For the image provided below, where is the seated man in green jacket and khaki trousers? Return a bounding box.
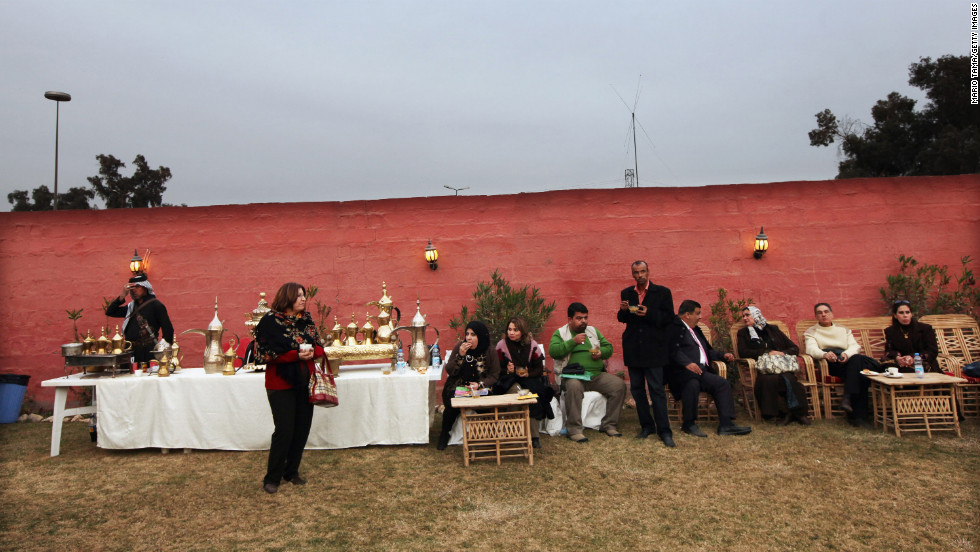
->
[548,303,626,443]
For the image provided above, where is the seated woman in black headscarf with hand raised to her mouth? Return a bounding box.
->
[436,320,500,450]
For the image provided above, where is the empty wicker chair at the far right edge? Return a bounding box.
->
[920,314,980,418]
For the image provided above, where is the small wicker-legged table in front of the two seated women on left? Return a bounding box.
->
[451,393,534,466]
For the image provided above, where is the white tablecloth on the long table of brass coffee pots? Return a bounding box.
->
[97,368,429,450]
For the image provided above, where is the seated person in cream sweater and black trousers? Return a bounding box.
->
[803,303,877,429]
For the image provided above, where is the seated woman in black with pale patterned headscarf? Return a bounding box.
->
[736,307,813,425]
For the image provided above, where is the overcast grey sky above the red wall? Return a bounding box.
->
[0,0,970,210]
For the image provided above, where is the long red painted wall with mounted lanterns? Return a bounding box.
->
[0,175,980,408]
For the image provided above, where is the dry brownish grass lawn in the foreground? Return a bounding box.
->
[0,410,980,552]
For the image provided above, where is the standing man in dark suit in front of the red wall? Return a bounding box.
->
[616,261,674,447]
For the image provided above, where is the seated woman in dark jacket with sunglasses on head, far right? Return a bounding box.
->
[882,299,940,372]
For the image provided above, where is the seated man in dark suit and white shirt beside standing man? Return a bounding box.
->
[667,299,752,437]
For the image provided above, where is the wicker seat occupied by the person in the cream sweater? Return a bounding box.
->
[796,316,892,419]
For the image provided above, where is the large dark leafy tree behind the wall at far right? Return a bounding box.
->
[809,55,980,178]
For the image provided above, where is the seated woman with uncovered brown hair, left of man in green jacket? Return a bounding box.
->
[494,318,555,448]
